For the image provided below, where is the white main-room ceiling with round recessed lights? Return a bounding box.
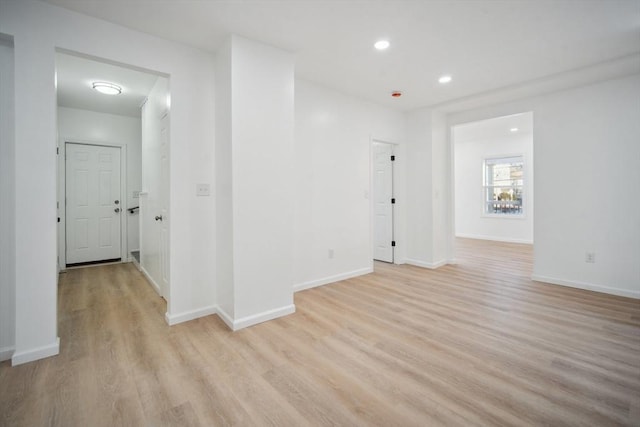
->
[46,0,640,110]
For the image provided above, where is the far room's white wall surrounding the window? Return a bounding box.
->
[454,123,534,243]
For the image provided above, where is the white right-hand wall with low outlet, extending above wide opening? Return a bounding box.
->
[449,74,640,298]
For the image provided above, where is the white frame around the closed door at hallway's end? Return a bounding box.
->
[58,138,130,271]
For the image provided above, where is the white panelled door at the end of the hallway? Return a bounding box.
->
[66,143,122,264]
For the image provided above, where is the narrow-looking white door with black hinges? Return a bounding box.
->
[373,142,393,262]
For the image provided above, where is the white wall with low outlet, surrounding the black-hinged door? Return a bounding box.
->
[292,79,406,290]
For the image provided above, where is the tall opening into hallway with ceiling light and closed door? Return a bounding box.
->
[56,50,170,301]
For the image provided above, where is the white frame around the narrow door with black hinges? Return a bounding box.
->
[366,136,406,269]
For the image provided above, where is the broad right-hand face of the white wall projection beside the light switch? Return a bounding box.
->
[231,36,294,319]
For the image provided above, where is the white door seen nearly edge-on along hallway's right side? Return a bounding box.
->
[158,113,169,301]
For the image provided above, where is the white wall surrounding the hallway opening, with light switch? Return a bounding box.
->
[0,2,215,364]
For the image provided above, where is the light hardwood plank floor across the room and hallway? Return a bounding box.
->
[0,239,640,426]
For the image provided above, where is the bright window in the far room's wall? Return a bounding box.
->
[484,156,524,215]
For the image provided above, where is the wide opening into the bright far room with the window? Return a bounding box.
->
[451,112,534,268]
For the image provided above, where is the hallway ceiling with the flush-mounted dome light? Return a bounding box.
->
[56,53,158,117]
